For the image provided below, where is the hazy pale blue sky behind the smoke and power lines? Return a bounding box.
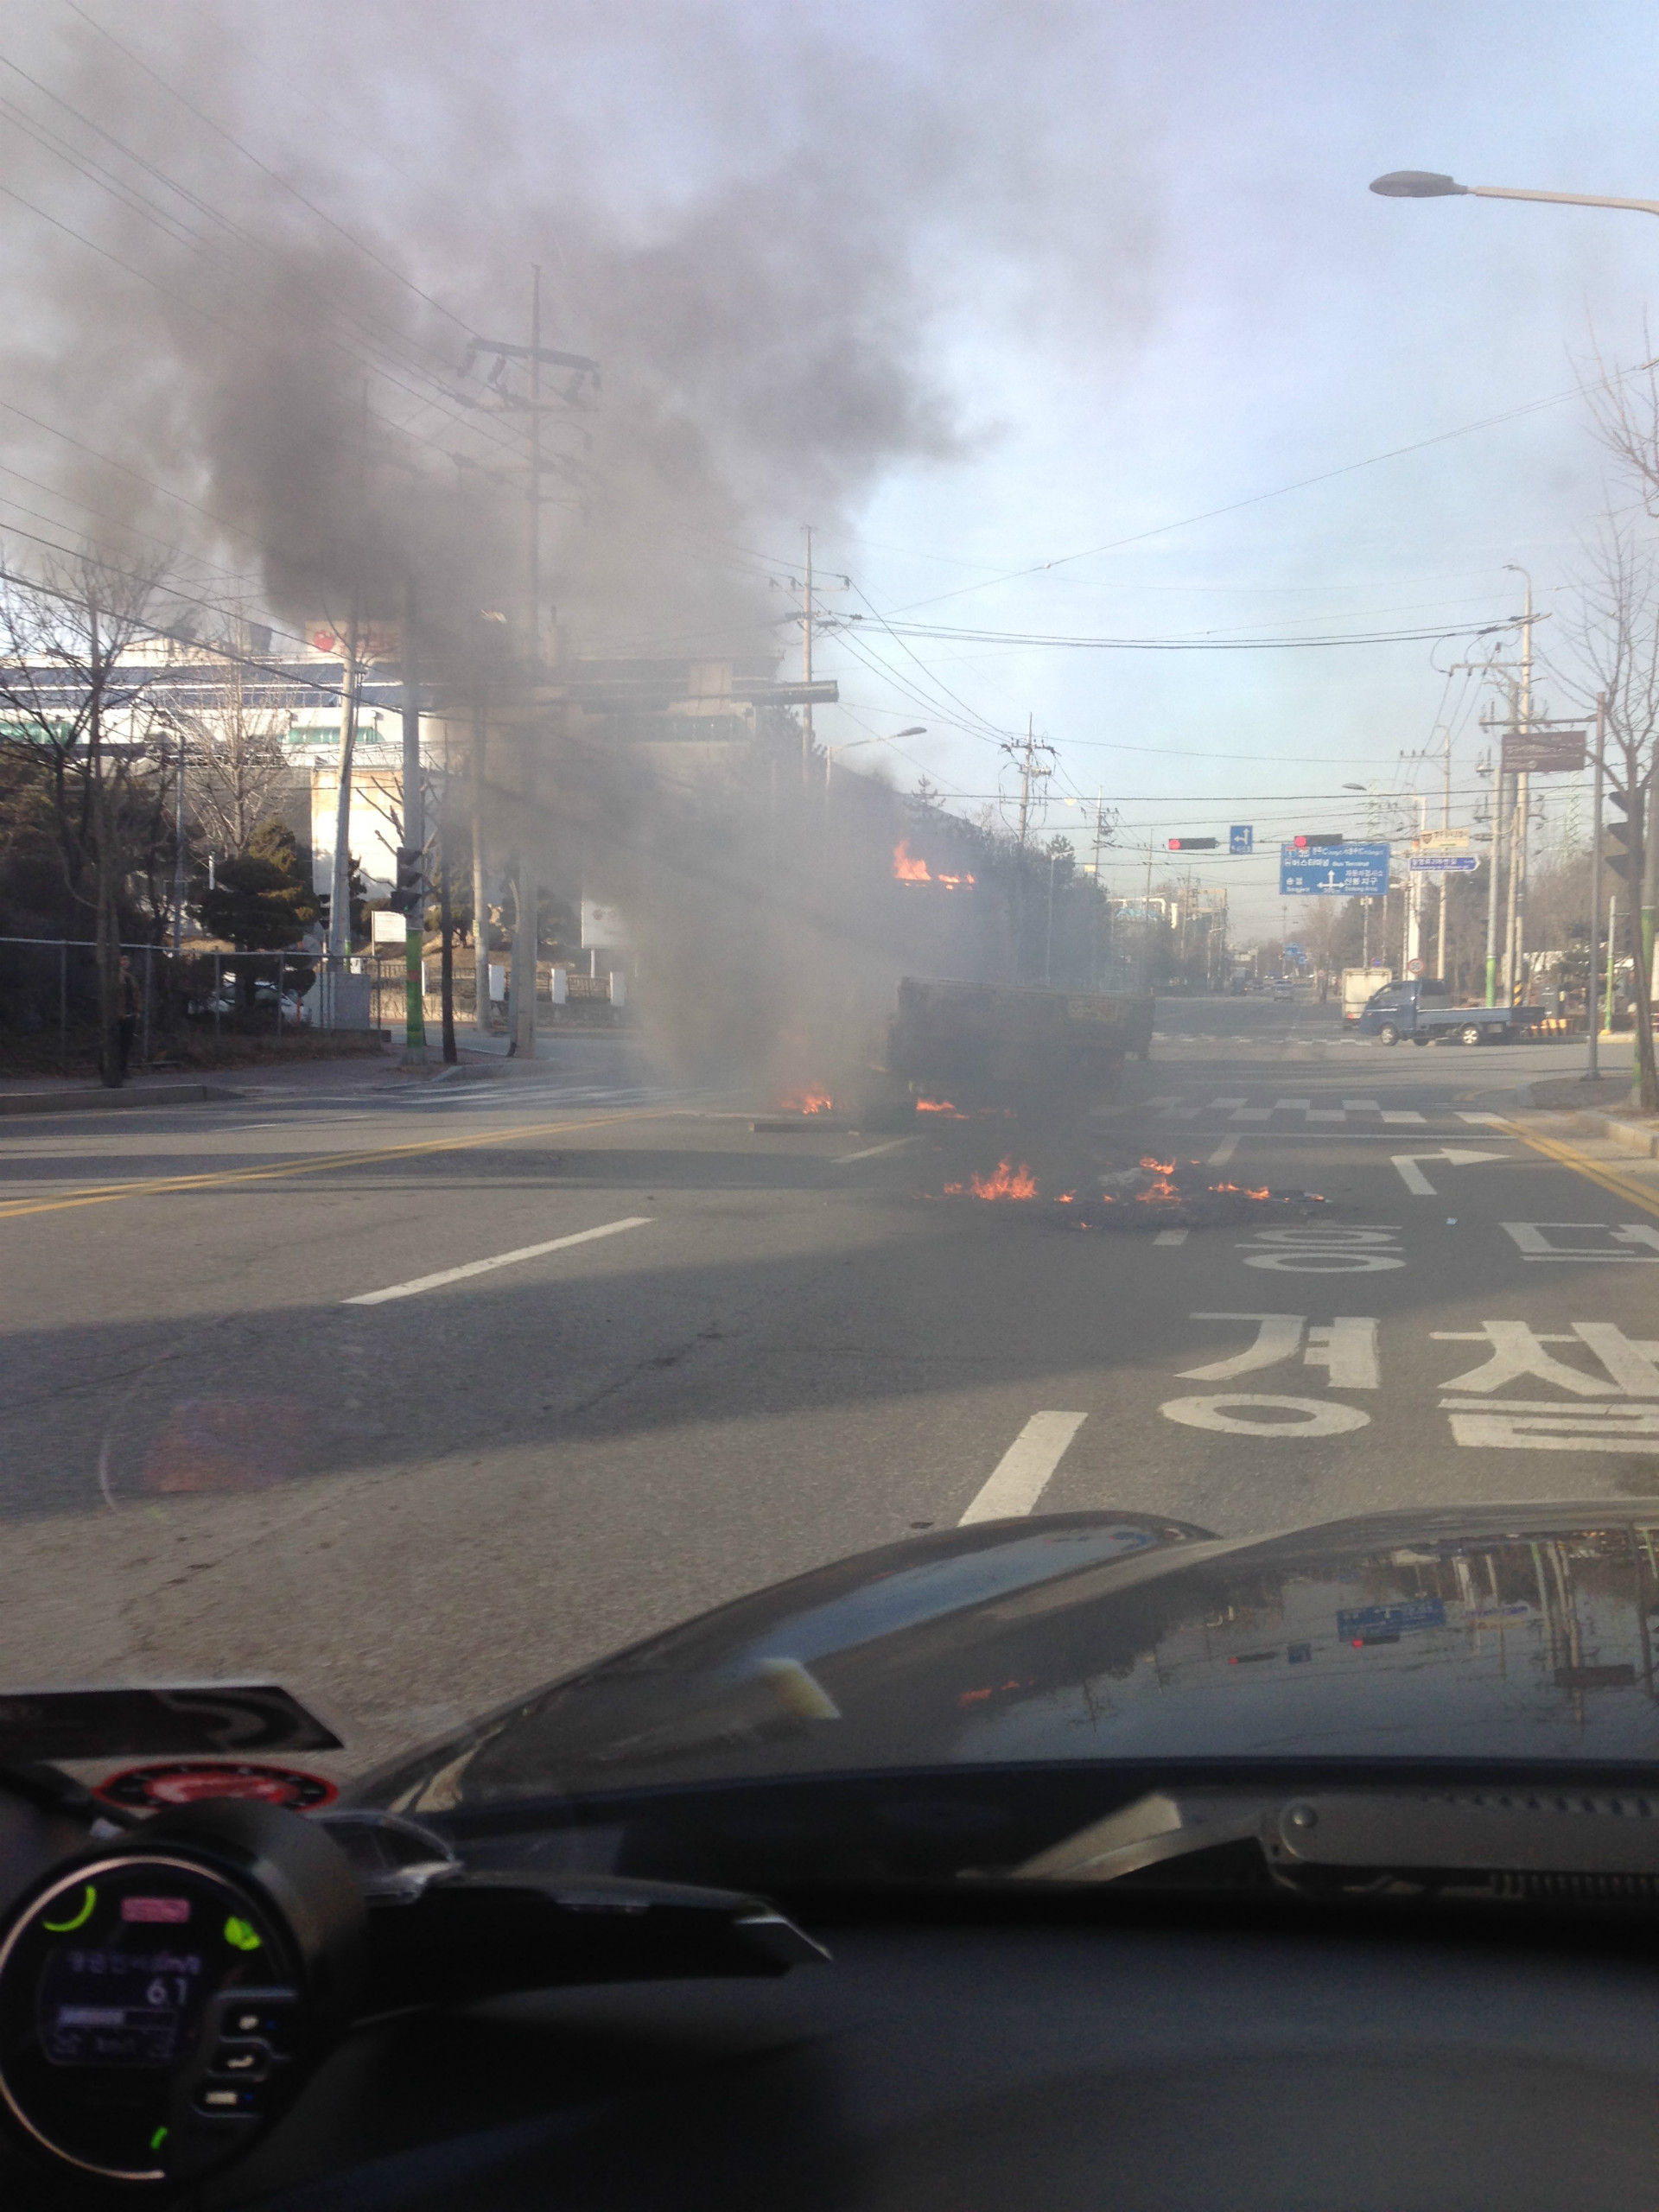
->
[0,0,1659,927]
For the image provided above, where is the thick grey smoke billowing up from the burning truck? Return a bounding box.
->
[0,0,1148,1075]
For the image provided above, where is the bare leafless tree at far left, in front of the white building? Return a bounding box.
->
[0,553,163,1089]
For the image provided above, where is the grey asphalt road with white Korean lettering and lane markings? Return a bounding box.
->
[0,1000,1659,1765]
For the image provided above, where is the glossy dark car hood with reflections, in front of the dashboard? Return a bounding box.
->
[354,1500,1659,1814]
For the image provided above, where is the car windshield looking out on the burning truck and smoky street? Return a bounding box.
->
[0,0,1659,1880]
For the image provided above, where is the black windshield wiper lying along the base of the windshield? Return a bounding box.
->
[1011,1787,1659,1897]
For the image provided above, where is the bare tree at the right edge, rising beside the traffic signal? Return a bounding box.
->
[1555,512,1659,1113]
